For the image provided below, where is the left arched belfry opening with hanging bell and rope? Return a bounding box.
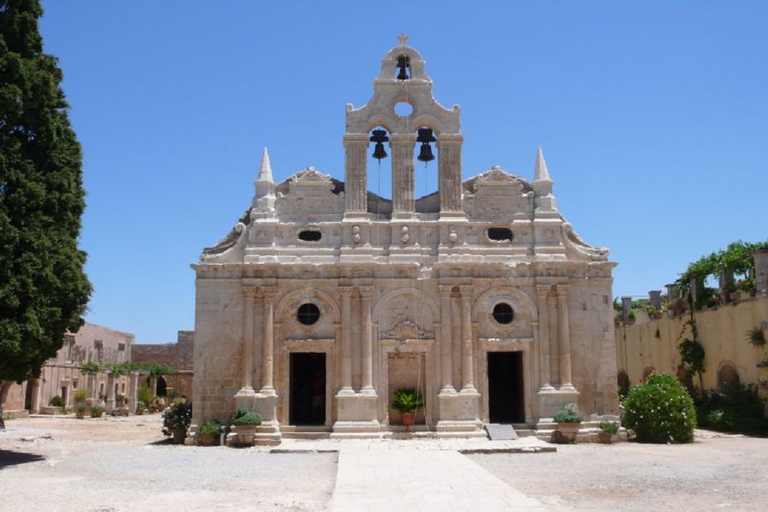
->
[368,125,392,215]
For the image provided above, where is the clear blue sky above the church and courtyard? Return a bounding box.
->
[41,0,768,343]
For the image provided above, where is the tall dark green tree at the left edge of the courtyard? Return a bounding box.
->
[0,0,91,428]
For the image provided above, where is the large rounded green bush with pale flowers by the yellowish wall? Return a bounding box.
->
[624,374,696,443]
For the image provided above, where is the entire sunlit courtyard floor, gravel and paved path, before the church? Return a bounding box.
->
[0,414,768,511]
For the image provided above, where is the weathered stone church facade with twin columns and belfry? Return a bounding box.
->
[193,36,618,442]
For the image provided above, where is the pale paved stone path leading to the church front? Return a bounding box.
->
[331,447,546,512]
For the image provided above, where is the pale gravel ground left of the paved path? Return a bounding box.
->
[0,414,338,512]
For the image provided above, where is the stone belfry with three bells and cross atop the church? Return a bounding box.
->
[344,34,464,220]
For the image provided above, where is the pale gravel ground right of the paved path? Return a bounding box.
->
[470,431,768,512]
